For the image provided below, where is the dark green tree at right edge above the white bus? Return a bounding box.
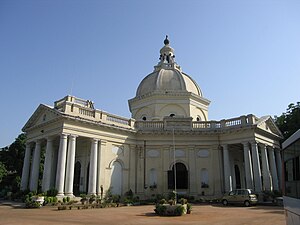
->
[275,102,300,141]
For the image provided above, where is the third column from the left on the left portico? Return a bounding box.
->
[42,137,53,192]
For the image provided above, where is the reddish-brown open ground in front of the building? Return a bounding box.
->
[0,202,285,225]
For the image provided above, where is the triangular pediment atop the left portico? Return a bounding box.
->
[22,104,61,132]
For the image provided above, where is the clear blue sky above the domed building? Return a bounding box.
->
[0,0,300,147]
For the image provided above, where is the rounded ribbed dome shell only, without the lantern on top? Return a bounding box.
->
[136,68,202,97]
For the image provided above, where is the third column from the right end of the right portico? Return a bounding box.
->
[259,143,272,191]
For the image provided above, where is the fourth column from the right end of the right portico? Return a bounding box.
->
[251,141,262,192]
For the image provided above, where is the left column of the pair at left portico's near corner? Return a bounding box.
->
[55,134,68,196]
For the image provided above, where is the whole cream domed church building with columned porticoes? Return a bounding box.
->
[21,37,282,198]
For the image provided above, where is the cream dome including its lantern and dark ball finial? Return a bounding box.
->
[136,36,202,97]
